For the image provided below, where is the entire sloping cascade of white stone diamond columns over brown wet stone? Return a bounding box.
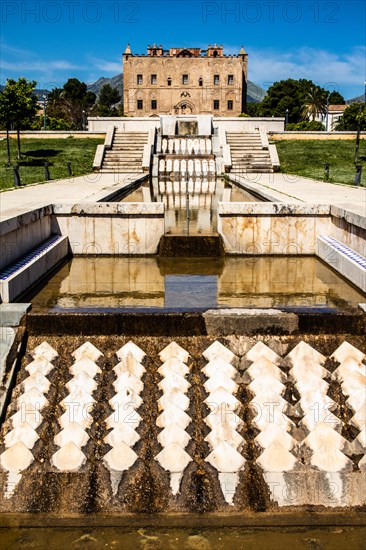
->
[0,339,366,511]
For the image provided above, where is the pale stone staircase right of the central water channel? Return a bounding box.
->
[226,132,274,174]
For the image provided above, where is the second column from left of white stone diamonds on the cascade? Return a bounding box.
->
[51,342,103,472]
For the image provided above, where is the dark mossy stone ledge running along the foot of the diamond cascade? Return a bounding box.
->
[0,507,366,528]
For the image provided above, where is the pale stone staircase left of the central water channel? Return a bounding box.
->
[100,129,148,173]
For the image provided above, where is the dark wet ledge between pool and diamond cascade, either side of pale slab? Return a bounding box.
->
[27,309,366,337]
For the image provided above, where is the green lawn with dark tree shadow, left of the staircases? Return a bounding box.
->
[0,138,104,189]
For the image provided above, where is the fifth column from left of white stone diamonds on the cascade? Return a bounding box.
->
[203,341,245,504]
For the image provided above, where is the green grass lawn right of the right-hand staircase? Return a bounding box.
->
[276,139,366,186]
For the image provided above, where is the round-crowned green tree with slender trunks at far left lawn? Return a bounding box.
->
[0,77,38,160]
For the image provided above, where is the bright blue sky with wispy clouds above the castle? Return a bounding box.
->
[0,0,366,99]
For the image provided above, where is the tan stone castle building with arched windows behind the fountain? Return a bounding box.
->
[123,44,248,117]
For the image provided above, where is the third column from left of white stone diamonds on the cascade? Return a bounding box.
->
[103,342,146,494]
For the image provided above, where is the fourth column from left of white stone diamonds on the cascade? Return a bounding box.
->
[155,342,192,495]
